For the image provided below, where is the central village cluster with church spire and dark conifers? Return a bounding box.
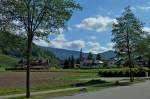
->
[62,49,114,69]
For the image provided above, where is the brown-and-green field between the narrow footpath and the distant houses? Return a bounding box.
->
[0,72,97,95]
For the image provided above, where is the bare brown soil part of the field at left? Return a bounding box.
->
[0,72,80,88]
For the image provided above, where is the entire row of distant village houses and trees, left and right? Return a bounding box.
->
[13,49,148,69]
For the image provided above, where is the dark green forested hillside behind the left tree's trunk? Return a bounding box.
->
[0,32,59,67]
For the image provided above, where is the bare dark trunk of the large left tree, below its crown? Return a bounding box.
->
[26,37,32,98]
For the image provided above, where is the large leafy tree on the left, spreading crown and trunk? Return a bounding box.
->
[0,0,81,98]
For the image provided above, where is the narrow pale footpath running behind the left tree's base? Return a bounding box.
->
[0,87,85,99]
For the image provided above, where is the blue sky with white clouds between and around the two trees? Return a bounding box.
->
[34,0,150,53]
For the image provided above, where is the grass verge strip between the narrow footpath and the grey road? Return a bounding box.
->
[9,80,143,99]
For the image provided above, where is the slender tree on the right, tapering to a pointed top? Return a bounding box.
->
[112,6,143,81]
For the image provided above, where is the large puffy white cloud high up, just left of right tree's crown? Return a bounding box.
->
[76,16,116,32]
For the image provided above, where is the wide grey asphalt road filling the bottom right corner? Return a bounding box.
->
[55,81,150,99]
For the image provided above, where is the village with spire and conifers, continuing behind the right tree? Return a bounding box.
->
[62,49,149,69]
